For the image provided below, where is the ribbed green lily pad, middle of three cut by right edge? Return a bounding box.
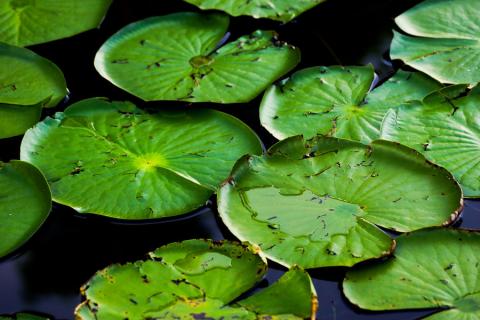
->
[382,86,480,198]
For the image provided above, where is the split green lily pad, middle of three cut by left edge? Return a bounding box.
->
[0,43,67,139]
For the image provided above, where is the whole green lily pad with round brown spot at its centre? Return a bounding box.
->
[95,12,300,103]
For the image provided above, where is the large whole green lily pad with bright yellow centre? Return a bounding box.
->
[21,99,262,219]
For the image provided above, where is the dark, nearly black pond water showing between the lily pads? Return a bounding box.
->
[0,0,480,320]
